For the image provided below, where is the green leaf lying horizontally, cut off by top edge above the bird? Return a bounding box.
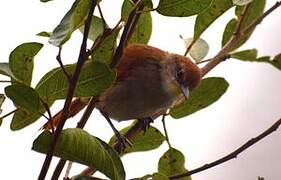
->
[156,0,212,17]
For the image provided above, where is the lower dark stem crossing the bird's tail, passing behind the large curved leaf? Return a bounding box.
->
[51,97,97,180]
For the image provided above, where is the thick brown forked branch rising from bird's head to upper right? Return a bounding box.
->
[201,1,281,77]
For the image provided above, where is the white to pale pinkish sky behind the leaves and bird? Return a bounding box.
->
[0,0,281,180]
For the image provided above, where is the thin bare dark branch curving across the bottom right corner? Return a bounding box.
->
[169,119,281,179]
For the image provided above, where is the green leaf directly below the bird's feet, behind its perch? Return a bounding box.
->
[109,123,165,154]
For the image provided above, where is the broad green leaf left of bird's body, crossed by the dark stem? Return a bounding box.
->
[35,61,115,103]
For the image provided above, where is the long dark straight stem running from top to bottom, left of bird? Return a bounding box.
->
[38,0,97,180]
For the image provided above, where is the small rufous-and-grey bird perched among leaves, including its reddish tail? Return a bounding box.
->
[44,44,201,148]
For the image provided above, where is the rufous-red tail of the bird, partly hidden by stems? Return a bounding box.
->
[41,98,89,130]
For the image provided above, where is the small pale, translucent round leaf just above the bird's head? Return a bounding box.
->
[184,38,210,63]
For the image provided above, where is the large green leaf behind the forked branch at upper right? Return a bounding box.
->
[222,0,266,50]
